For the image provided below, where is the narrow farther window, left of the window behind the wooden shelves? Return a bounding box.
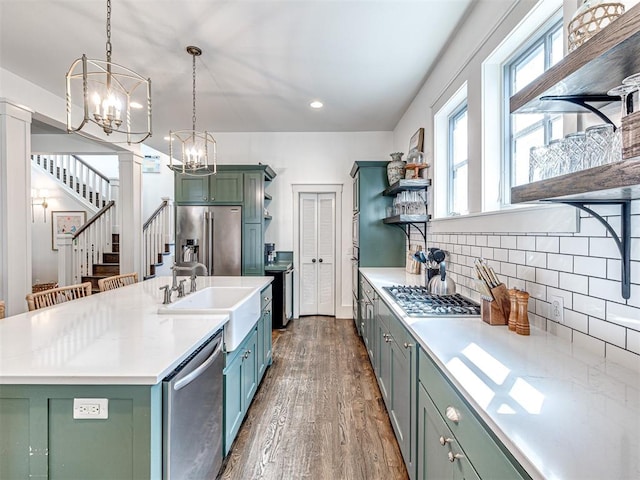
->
[447,102,469,215]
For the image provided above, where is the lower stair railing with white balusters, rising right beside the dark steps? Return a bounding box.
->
[72,200,116,283]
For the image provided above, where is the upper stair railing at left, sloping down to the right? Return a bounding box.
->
[31,154,113,209]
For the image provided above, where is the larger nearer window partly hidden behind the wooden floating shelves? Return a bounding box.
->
[504,19,563,191]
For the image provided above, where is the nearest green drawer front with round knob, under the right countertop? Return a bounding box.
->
[418,349,530,480]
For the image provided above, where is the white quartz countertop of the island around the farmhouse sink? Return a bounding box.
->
[0,277,273,385]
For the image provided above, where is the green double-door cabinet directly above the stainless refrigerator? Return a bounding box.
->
[175,172,244,204]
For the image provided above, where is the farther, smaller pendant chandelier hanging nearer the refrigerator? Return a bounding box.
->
[169,45,217,176]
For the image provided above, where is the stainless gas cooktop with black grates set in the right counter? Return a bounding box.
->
[382,285,480,317]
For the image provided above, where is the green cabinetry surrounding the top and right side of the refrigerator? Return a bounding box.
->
[175,165,276,276]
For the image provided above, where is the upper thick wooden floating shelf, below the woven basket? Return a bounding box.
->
[510,5,640,113]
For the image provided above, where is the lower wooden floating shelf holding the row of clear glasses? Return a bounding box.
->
[511,158,640,203]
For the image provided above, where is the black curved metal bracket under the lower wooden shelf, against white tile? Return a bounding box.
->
[548,199,631,300]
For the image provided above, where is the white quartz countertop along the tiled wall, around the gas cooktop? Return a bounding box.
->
[360,268,640,480]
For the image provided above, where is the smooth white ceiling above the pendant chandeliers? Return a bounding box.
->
[0,0,472,151]
